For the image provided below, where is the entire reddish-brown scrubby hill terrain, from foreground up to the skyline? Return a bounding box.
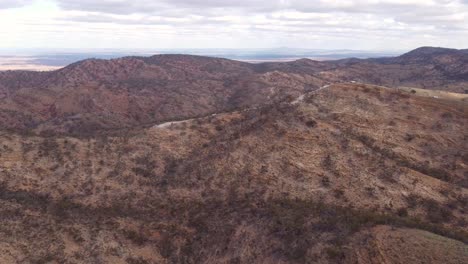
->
[0,48,468,263]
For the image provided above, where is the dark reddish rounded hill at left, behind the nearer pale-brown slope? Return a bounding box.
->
[0,55,322,135]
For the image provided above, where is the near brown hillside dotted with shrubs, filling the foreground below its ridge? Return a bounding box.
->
[0,83,468,263]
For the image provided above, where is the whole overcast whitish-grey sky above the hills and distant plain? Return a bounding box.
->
[0,0,468,50]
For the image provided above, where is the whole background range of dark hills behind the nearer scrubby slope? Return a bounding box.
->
[0,48,468,136]
